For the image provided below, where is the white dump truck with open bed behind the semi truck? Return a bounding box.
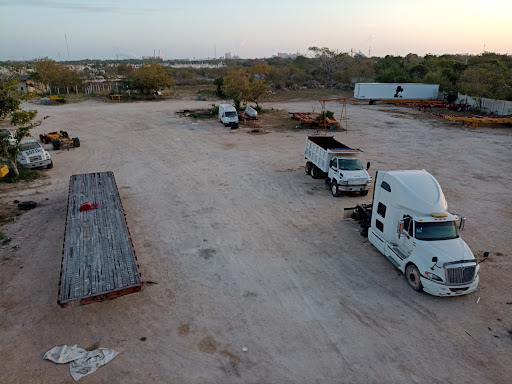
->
[304,136,372,197]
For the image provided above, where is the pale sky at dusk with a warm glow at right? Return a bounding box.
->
[0,0,512,60]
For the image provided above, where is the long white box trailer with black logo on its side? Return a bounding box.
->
[354,83,439,104]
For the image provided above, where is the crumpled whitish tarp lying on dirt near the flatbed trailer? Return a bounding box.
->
[43,344,118,381]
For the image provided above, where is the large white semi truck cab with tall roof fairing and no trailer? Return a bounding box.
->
[345,170,489,296]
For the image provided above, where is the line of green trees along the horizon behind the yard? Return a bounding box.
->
[0,47,512,100]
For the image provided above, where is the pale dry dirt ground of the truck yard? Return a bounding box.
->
[0,97,512,384]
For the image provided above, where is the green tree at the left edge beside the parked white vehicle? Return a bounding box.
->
[0,78,48,176]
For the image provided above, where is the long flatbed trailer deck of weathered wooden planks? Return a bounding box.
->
[58,172,143,307]
